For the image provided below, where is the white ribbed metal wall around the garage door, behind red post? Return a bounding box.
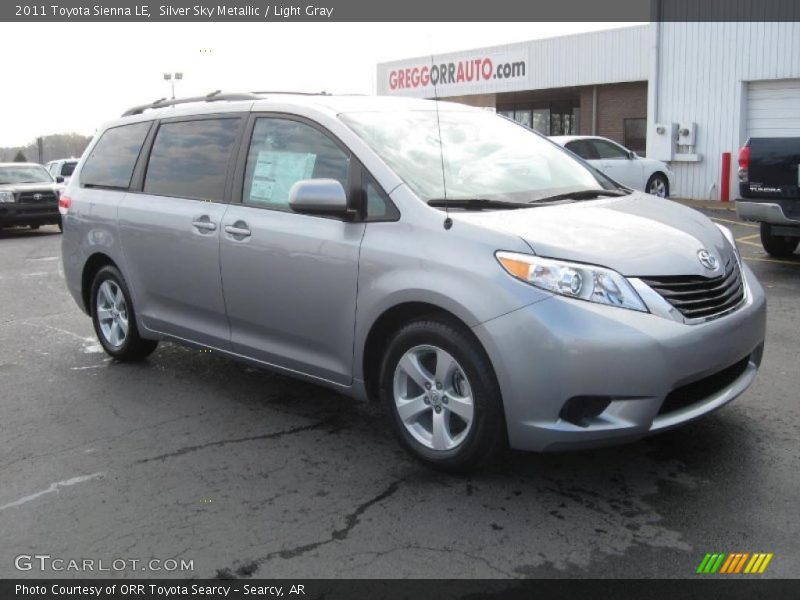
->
[647,22,800,199]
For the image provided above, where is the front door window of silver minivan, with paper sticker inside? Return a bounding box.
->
[242,117,350,210]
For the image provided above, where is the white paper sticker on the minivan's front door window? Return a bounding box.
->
[250,150,317,204]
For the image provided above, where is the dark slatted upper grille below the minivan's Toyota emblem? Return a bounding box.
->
[641,258,744,319]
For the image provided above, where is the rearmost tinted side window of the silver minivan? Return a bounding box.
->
[81,122,150,190]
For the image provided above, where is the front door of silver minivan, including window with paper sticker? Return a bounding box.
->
[221,117,365,384]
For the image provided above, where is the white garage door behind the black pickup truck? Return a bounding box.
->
[747,79,800,137]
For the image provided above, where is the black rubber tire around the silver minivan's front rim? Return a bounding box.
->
[379,317,507,472]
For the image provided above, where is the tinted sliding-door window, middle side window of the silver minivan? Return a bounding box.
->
[144,119,240,201]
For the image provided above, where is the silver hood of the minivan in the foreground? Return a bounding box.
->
[451,193,733,277]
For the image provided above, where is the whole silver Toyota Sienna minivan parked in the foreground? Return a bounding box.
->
[60,94,766,469]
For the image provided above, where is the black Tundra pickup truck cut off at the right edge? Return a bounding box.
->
[736,137,800,257]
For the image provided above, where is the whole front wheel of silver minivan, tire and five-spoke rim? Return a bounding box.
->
[380,318,505,471]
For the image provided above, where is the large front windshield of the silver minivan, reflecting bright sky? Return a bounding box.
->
[340,109,616,202]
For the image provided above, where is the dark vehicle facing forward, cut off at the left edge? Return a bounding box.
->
[0,163,61,229]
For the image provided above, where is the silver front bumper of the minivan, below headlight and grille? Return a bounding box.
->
[474,266,766,451]
